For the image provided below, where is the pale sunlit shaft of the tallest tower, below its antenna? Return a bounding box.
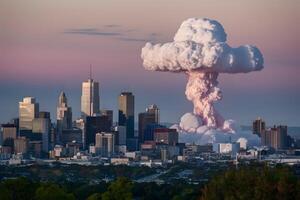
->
[81,78,100,117]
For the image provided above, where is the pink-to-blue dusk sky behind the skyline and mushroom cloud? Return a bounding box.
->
[0,1,300,126]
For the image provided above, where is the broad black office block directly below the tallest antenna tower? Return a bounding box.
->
[84,116,110,149]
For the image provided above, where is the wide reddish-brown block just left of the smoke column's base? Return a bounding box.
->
[154,128,178,146]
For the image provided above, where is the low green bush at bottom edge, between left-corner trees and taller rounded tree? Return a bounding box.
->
[35,183,75,200]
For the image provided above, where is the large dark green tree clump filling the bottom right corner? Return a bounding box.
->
[201,167,300,200]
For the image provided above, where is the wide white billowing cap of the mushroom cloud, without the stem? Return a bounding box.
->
[141,18,264,73]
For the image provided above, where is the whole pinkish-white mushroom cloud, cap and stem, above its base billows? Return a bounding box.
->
[141,18,263,132]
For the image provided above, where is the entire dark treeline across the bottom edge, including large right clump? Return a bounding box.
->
[0,167,300,200]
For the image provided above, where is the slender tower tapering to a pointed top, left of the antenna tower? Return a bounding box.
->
[56,92,72,131]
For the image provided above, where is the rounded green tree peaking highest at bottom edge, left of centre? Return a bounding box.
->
[101,177,133,200]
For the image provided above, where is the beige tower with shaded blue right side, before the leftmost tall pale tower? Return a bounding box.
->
[30,112,51,152]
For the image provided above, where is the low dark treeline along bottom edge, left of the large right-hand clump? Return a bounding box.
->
[0,177,200,200]
